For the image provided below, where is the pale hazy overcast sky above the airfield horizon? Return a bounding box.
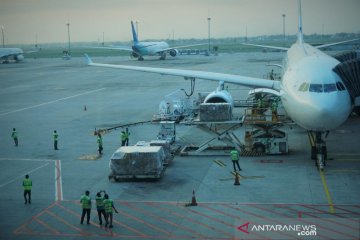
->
[0,0,360,44]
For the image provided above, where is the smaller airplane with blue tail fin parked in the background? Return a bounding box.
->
[96,21,204,61]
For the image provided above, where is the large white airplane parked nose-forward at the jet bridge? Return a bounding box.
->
[86,0,360,170]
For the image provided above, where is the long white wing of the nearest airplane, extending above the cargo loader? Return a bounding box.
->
[85,54,280,90]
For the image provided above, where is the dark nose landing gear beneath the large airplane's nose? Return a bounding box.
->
[309,131,329,171]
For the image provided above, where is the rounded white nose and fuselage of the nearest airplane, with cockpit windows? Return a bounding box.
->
[280,42,352,132]
